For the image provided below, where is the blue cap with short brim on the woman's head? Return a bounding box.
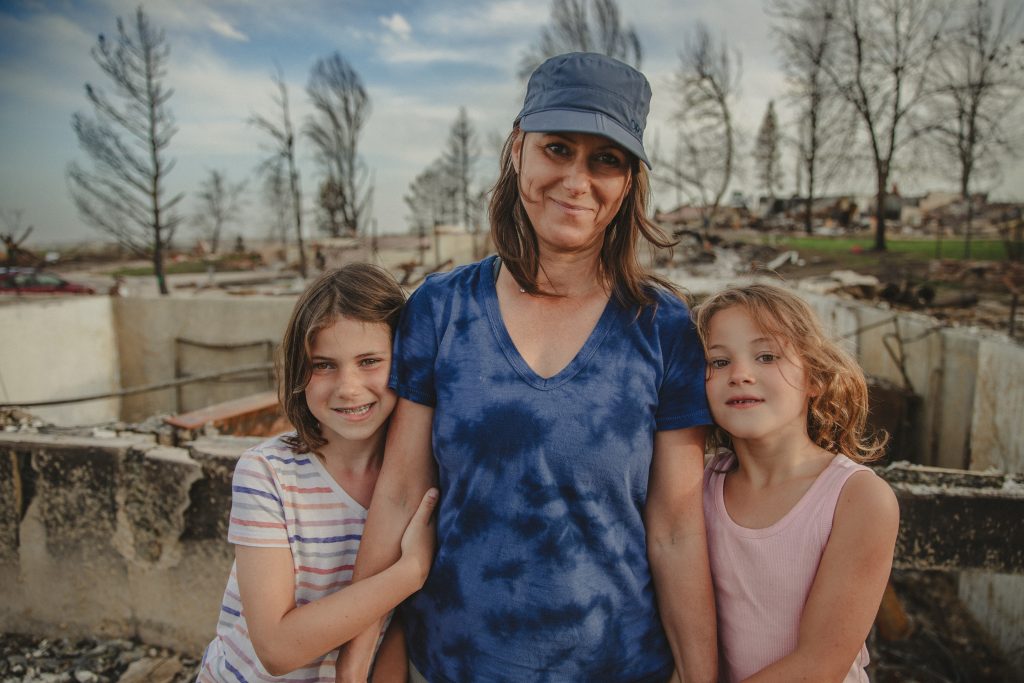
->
[516,52,651,168]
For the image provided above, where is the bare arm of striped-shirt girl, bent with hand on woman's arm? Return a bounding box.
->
[234,489,437,676]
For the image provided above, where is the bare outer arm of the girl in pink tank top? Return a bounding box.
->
[746,472,899,683]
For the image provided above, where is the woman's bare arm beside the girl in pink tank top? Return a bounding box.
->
[644,427,718,683]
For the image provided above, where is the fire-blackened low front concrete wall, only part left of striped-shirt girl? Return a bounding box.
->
[0,434,247,653]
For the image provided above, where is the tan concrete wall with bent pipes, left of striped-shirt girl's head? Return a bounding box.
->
[114,296,295,422]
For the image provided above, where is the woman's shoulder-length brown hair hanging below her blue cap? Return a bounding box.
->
[488,124,683,306]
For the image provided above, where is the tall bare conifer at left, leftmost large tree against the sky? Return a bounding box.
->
[68,7,183,294]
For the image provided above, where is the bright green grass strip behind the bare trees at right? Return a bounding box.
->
[774,237,1008,261]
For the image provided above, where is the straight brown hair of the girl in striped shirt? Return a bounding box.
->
[278,263,406,453]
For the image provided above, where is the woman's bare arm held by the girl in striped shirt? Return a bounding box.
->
[337,398,437,683]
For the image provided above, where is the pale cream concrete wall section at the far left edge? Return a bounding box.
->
[0,296,121,426]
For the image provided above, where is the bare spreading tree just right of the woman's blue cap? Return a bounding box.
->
[657,22,740,226]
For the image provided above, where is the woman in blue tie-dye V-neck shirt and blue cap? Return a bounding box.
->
[339,53,717,683]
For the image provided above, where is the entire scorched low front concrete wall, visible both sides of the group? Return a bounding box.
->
[0,433,1024,667]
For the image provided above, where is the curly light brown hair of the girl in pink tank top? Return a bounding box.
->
[693,285,889,463]
